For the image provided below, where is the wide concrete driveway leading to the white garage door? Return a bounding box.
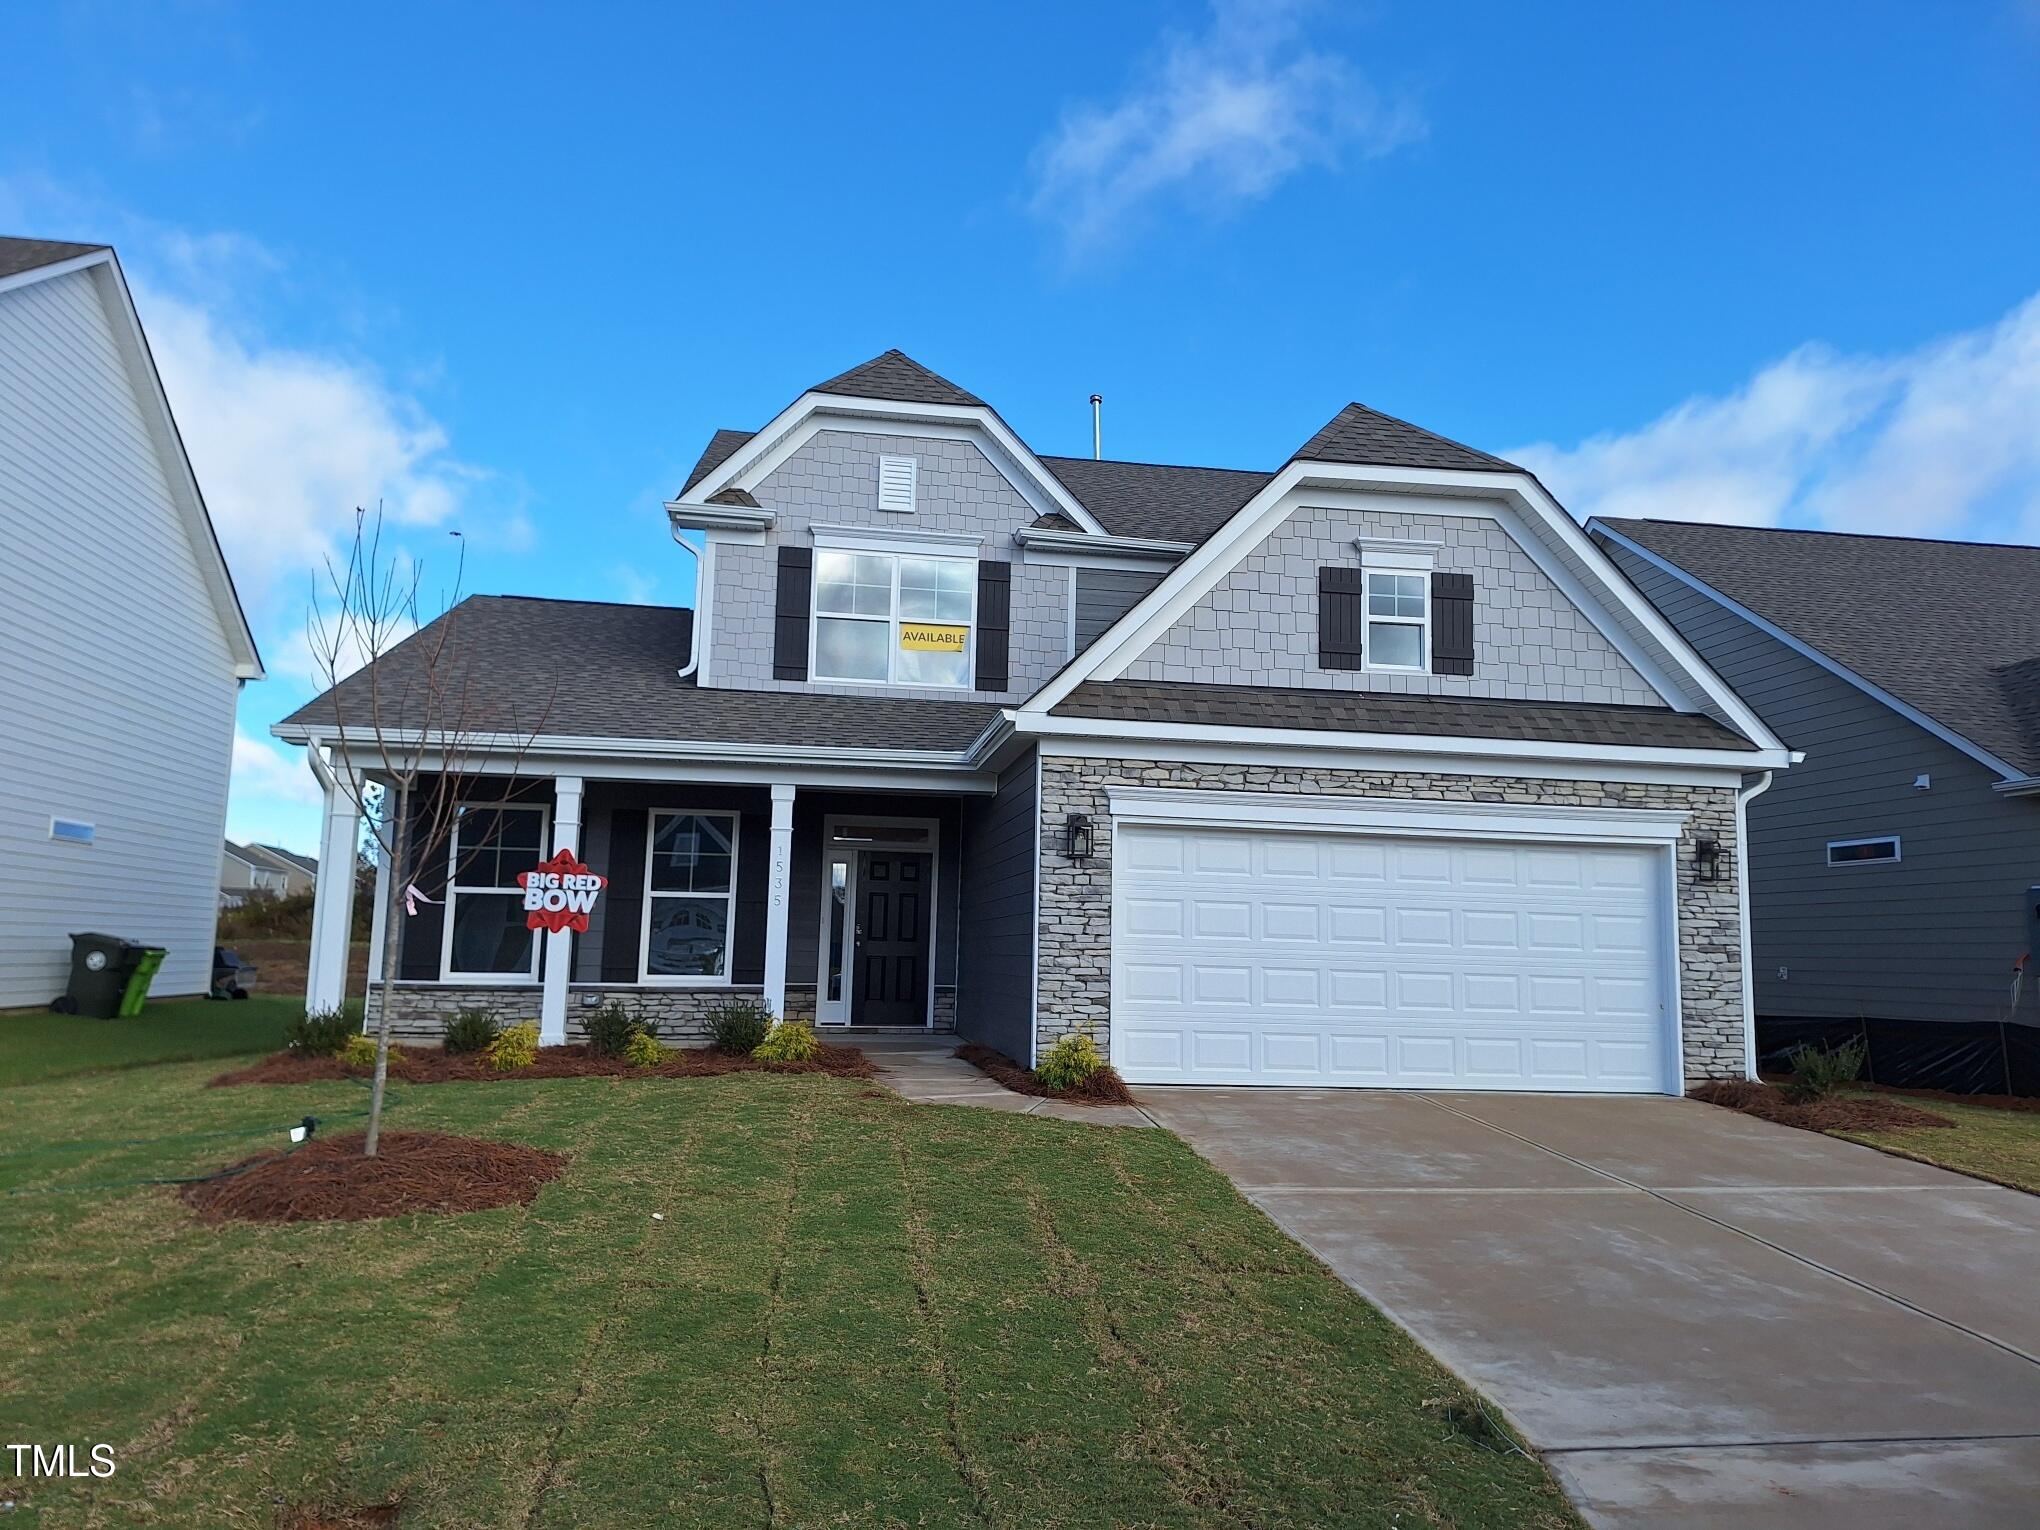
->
[1138,1087,2040,1530]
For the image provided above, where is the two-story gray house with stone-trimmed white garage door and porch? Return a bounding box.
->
[275,351,1785,1091]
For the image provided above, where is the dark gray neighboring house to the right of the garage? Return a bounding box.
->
[1589,520,2040,1093]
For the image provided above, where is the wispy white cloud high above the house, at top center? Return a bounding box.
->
[1028,0,1422,255]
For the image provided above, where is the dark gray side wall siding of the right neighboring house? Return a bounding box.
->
[1610,547,2040,1020]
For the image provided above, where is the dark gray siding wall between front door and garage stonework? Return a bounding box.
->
[957,751,1034,1063]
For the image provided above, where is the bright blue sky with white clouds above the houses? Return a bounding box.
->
[0,0,2040,849]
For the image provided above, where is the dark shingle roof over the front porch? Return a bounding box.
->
[284,596,1000,753]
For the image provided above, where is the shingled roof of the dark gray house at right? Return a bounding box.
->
[1589,518,2040,775]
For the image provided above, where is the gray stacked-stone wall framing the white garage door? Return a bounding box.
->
[1034,757,1744,1087]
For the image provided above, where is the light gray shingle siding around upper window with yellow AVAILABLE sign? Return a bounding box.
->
[708,430,1069,702]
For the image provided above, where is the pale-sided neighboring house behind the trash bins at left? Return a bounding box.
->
[0,239,261,1006]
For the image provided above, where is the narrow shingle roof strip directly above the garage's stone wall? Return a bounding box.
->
[1055,679,1754,749]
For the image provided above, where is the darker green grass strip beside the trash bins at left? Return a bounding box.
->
[0,996,304,1087]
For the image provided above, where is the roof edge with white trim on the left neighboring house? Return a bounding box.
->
[0,237,263,679]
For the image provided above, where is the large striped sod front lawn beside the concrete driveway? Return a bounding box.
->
[0,1052,1577,1530]
